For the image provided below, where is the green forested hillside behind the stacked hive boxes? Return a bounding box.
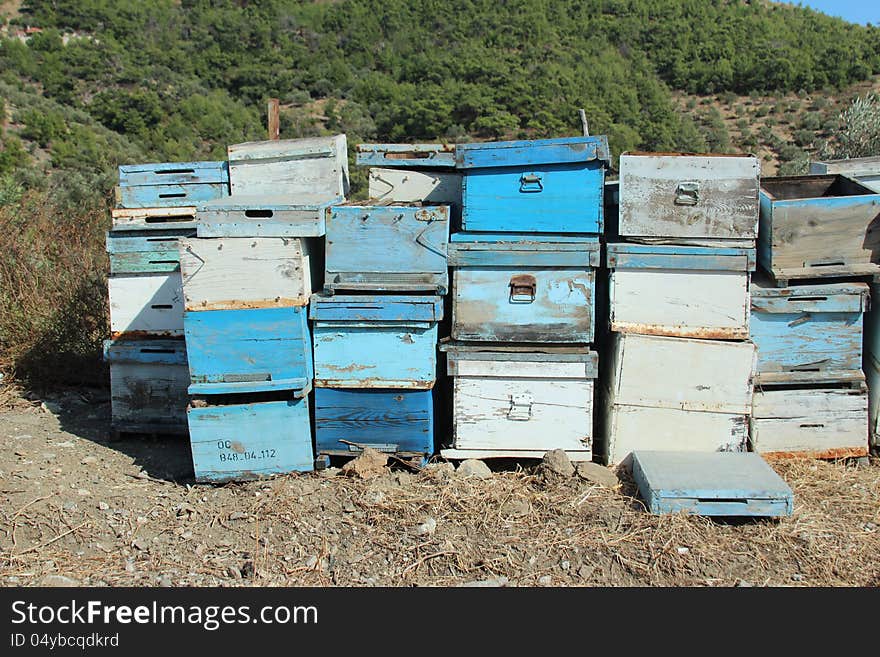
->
[0,0,880,384]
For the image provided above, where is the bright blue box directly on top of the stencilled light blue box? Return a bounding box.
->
[183,306,312,395]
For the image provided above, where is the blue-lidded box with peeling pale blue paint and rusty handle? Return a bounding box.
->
[449,233,600,344]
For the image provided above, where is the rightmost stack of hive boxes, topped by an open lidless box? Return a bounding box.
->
[751,167,880,458]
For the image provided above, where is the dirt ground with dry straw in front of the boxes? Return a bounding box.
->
[0,390,880,586]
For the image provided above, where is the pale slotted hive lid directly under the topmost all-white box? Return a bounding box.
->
[196,195,343,237]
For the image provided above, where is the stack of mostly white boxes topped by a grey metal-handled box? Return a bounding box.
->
[603,153,760,463]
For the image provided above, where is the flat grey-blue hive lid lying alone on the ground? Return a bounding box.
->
[632,450,794,517]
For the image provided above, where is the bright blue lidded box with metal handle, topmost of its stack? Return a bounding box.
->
[455,136,610,234]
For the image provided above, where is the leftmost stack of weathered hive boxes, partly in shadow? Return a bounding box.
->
[104,162,229,434]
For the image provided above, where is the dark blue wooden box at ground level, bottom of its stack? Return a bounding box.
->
[315,388,434,457]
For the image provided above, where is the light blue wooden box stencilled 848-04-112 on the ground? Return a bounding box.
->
[187,399,315,483]
